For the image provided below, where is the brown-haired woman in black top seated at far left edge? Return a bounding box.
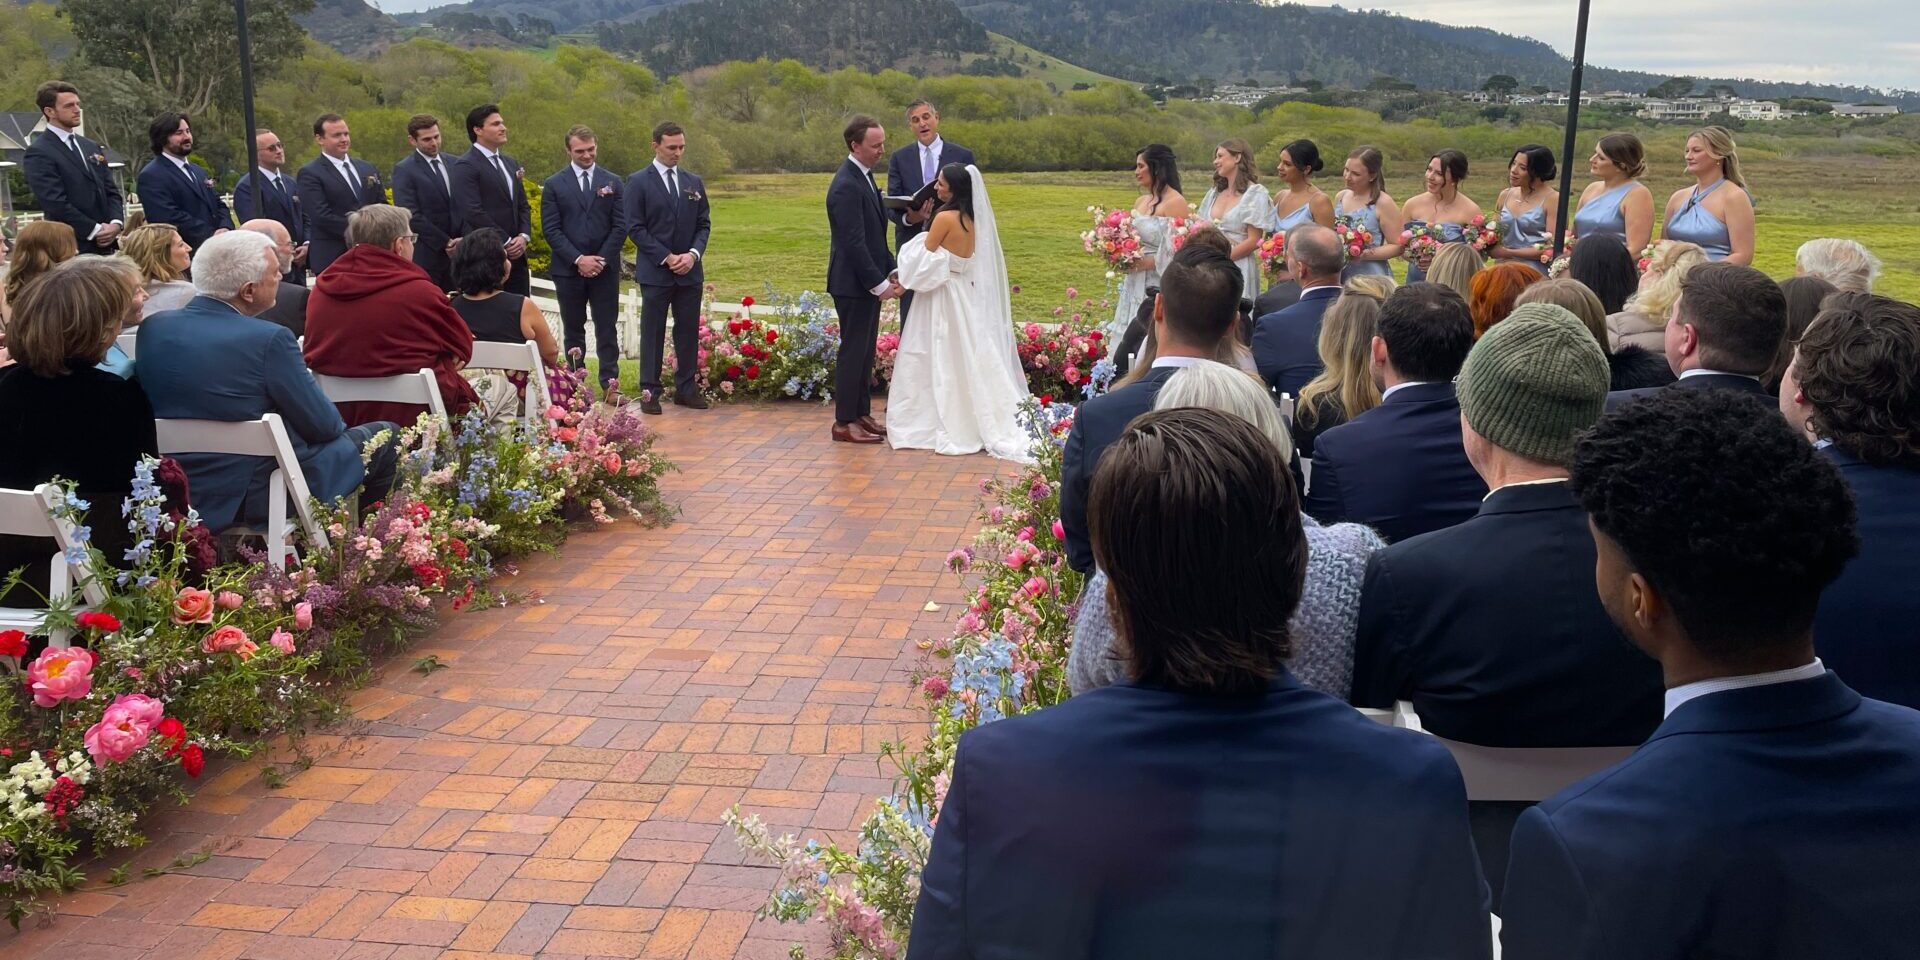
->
[0,255,159,607]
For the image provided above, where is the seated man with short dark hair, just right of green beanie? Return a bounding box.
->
[1607,261,1788,411]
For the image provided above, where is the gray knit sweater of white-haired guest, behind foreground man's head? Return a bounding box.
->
[1068,515,1386,701]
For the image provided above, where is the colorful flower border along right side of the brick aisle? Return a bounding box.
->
[728,401,1083,960]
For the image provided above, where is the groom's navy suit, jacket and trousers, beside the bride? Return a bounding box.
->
[828,157,893,424]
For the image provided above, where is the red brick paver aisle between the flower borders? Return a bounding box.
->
[11,403,1000,960]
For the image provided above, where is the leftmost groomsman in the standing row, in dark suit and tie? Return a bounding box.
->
[23,81,127,253]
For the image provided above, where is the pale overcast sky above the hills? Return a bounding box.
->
[366,0,1920,88]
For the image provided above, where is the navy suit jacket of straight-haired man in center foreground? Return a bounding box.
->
[906,674,1492,960]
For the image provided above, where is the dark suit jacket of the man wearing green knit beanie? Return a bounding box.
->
[1354,484,1665,747]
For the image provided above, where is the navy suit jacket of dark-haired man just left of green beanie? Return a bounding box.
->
[1308,382,1486,543]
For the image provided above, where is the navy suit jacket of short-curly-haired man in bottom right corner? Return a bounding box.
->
[1501,672,1920,960]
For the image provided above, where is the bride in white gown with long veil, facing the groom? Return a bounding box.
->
[887,163,1031,463]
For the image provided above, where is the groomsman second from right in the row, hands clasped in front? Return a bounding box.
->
[540,127,626,386]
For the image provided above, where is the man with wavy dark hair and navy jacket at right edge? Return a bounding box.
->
[1780,295,1920,708]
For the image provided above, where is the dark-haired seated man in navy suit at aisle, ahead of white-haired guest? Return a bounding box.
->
[1060,244,1240,574]
